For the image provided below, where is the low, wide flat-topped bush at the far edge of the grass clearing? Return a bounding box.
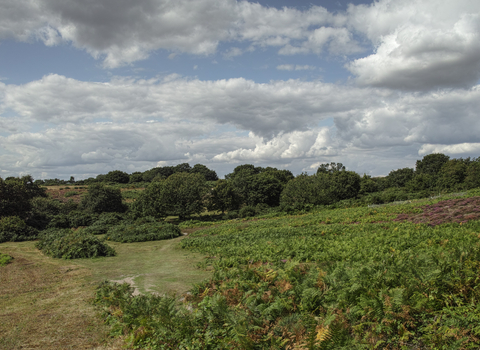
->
[107,222,181,243]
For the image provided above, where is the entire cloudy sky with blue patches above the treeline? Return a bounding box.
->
[0,0,480,179]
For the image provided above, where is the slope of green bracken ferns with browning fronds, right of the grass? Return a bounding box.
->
[97,193,480,349]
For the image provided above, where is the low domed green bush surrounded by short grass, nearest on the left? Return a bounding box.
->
[36,229,116,259]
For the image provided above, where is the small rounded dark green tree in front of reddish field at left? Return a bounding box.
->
[80,183,126,214]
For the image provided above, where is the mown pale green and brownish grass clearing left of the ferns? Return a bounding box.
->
[0,237,209,350]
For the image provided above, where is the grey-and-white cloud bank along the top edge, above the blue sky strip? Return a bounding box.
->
[0,0,356,68]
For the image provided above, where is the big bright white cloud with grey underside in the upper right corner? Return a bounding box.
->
[347,0,480,91]
